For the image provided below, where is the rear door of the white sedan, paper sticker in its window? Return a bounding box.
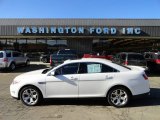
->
[79,62,116,97]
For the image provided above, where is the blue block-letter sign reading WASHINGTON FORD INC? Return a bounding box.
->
[17,27,141,35]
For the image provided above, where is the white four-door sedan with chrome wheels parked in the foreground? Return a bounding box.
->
[10,58,150,107]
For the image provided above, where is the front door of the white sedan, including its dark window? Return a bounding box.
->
[46,63,79,98]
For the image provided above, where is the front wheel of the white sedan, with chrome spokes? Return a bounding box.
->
[20,86,42,106]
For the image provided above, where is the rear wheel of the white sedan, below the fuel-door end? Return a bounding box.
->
[107,87,131,108]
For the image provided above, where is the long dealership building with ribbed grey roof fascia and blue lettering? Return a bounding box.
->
[0,19,160,54]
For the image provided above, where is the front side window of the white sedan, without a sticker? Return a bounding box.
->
[55,63,79,75]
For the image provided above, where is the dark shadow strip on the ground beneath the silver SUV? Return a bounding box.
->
[0,64,48,73]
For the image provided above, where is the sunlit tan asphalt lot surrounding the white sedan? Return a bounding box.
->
[0,63,160,120]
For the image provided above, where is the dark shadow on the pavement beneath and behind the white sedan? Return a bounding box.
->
[41,88,160,108]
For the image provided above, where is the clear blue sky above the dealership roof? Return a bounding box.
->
[0,0,160,18]
